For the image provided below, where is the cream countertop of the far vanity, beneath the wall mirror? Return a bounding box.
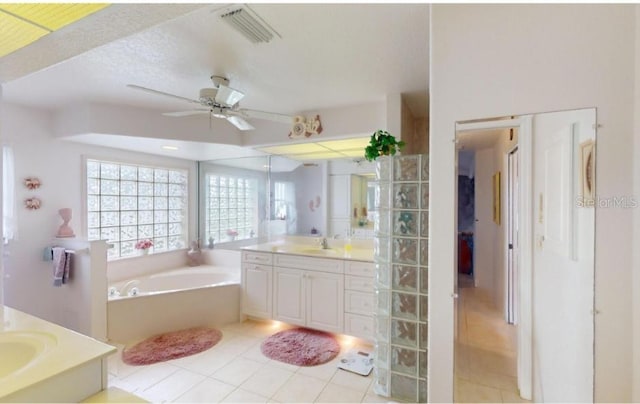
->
[242,242,373,262]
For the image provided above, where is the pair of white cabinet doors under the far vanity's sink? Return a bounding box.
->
[273,254,344,333]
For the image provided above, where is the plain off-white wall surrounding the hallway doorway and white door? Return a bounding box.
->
[429,4,635,401]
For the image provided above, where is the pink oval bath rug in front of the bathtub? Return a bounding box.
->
[122,327,222,366]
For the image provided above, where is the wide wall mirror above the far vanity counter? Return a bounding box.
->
[198,155,375,245]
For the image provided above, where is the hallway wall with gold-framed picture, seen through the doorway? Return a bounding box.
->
[473,148,496,296]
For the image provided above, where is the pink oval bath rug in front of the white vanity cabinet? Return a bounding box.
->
[260,328,340,366]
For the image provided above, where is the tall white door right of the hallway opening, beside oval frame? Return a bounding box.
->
[533,109,596,402]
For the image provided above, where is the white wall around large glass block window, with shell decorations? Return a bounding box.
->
[0,104,196,324]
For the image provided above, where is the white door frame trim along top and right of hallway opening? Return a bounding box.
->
[453,115,533,400]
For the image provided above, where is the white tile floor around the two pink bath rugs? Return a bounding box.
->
[108,321,389,403]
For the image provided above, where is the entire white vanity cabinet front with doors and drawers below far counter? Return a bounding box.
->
[242,249,375,341]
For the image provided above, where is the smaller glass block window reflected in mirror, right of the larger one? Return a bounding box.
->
[205,174,258,242]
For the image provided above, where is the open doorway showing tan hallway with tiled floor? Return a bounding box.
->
[454,124,520,402]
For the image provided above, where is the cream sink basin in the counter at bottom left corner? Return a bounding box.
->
[0,331,57,379]
